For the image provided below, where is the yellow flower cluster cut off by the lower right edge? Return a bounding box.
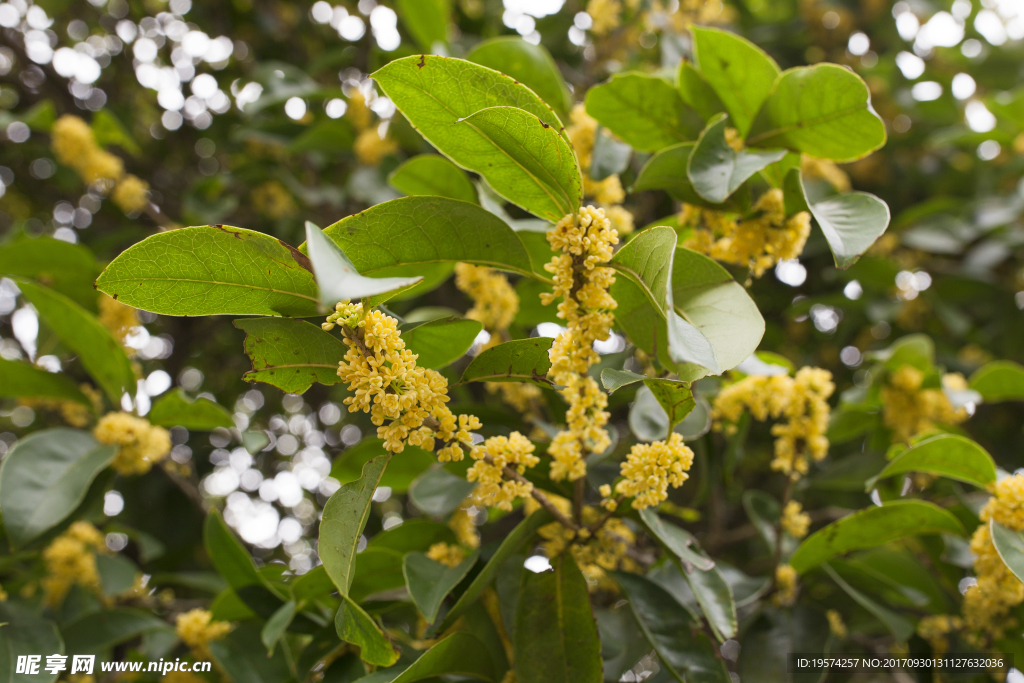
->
[963,474,1024,640]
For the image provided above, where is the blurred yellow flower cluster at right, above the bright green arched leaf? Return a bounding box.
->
[881,366,970,443]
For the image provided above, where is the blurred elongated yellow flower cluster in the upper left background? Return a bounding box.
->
[50,114,150,214]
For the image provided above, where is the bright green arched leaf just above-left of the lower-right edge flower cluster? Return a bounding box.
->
[865,434,995,492]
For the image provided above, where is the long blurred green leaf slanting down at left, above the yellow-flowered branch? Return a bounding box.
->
[14,278,135,405]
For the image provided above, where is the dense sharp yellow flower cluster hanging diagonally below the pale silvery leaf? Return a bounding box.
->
[331,302,480,462]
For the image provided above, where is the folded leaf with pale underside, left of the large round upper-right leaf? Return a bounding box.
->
[686,115,786,204]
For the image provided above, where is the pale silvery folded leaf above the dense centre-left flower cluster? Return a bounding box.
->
[305,220,423,307]
